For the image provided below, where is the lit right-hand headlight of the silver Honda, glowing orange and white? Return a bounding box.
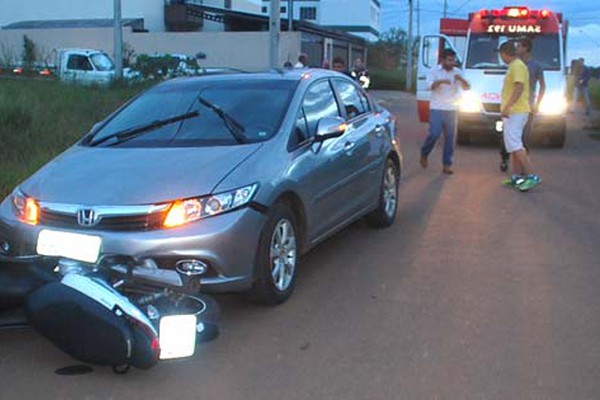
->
[163,183,258,228]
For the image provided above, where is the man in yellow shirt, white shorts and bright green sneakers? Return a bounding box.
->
[500,40,542,192]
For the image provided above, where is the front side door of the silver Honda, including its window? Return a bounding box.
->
[290,79,364,242]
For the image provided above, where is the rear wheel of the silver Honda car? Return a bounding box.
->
[367,158,400,228]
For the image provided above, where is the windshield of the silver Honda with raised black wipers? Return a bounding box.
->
[84,80,297,147]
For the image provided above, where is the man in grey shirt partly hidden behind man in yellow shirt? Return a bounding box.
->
[500,37,546,171]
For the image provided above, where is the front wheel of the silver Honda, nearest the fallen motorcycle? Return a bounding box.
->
[250,203,300,305]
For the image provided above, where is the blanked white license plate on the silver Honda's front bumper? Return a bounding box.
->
[36,229,102,263]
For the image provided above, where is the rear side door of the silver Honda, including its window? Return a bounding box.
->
[333,79,385,214]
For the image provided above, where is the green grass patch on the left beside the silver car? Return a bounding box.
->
[0,80,147,199]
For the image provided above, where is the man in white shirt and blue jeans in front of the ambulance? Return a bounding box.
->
[421,49,471,175]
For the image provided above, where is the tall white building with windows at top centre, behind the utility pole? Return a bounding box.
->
[261,0,381,41]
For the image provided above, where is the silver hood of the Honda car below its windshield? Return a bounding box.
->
[20,144,262,205]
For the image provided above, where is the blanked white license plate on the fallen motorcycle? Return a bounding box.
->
[158,315,197,360]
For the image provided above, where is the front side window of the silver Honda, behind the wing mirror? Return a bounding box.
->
[302,80,340,137]
